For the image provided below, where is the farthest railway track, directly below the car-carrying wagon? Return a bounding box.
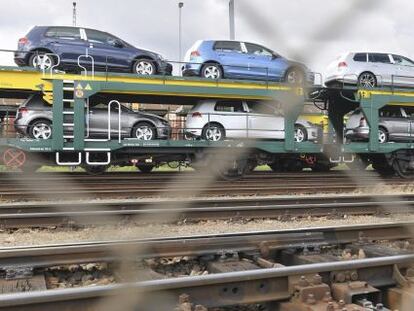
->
[0,172,410,200]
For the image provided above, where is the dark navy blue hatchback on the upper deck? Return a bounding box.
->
[14,26,172,75]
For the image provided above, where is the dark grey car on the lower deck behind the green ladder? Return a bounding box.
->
[14,95,171,140]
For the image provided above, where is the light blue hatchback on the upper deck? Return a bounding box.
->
[182,40,314,84]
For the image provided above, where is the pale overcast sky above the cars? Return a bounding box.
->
[0,0,414,72]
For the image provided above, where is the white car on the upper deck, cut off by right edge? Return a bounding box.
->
[325,52,414,88]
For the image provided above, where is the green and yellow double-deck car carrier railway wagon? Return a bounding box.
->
[0,62,414,178]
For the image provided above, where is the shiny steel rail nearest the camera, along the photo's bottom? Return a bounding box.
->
[0,254,414,311]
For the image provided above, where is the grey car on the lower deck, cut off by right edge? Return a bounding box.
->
[345,106,414,143]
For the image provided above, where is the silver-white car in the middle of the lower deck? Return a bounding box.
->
[184,100,321,142]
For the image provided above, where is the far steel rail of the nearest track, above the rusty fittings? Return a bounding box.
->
[0,222,414,270]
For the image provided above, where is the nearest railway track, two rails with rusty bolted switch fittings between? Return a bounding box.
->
[0,223,414,311]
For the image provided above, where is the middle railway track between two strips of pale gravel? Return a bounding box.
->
[0,195,414,229]
